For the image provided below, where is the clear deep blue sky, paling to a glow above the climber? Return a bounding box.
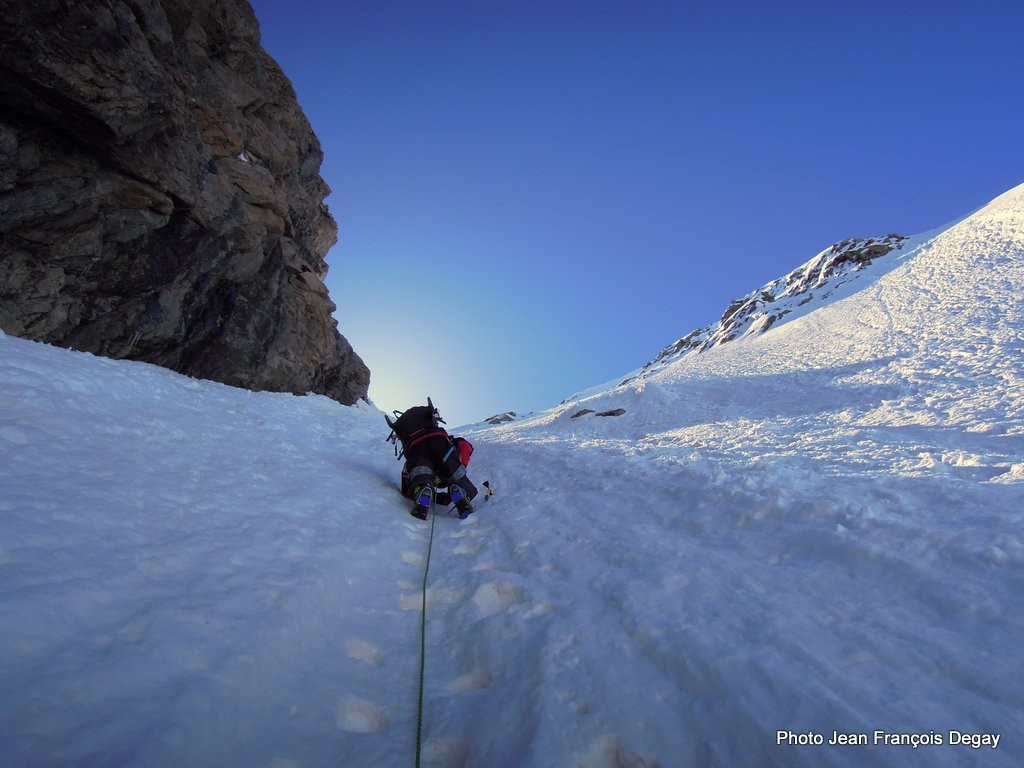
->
[245,0,1024,426]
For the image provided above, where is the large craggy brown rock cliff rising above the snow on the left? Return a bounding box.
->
[0,0,370,403]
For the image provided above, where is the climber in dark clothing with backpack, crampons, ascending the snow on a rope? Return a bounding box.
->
[384,397,477,520]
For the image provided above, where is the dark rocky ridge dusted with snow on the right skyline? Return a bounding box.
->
[642,234,907,372]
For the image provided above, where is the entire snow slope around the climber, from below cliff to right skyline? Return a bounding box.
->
[0,186,1024,768]
